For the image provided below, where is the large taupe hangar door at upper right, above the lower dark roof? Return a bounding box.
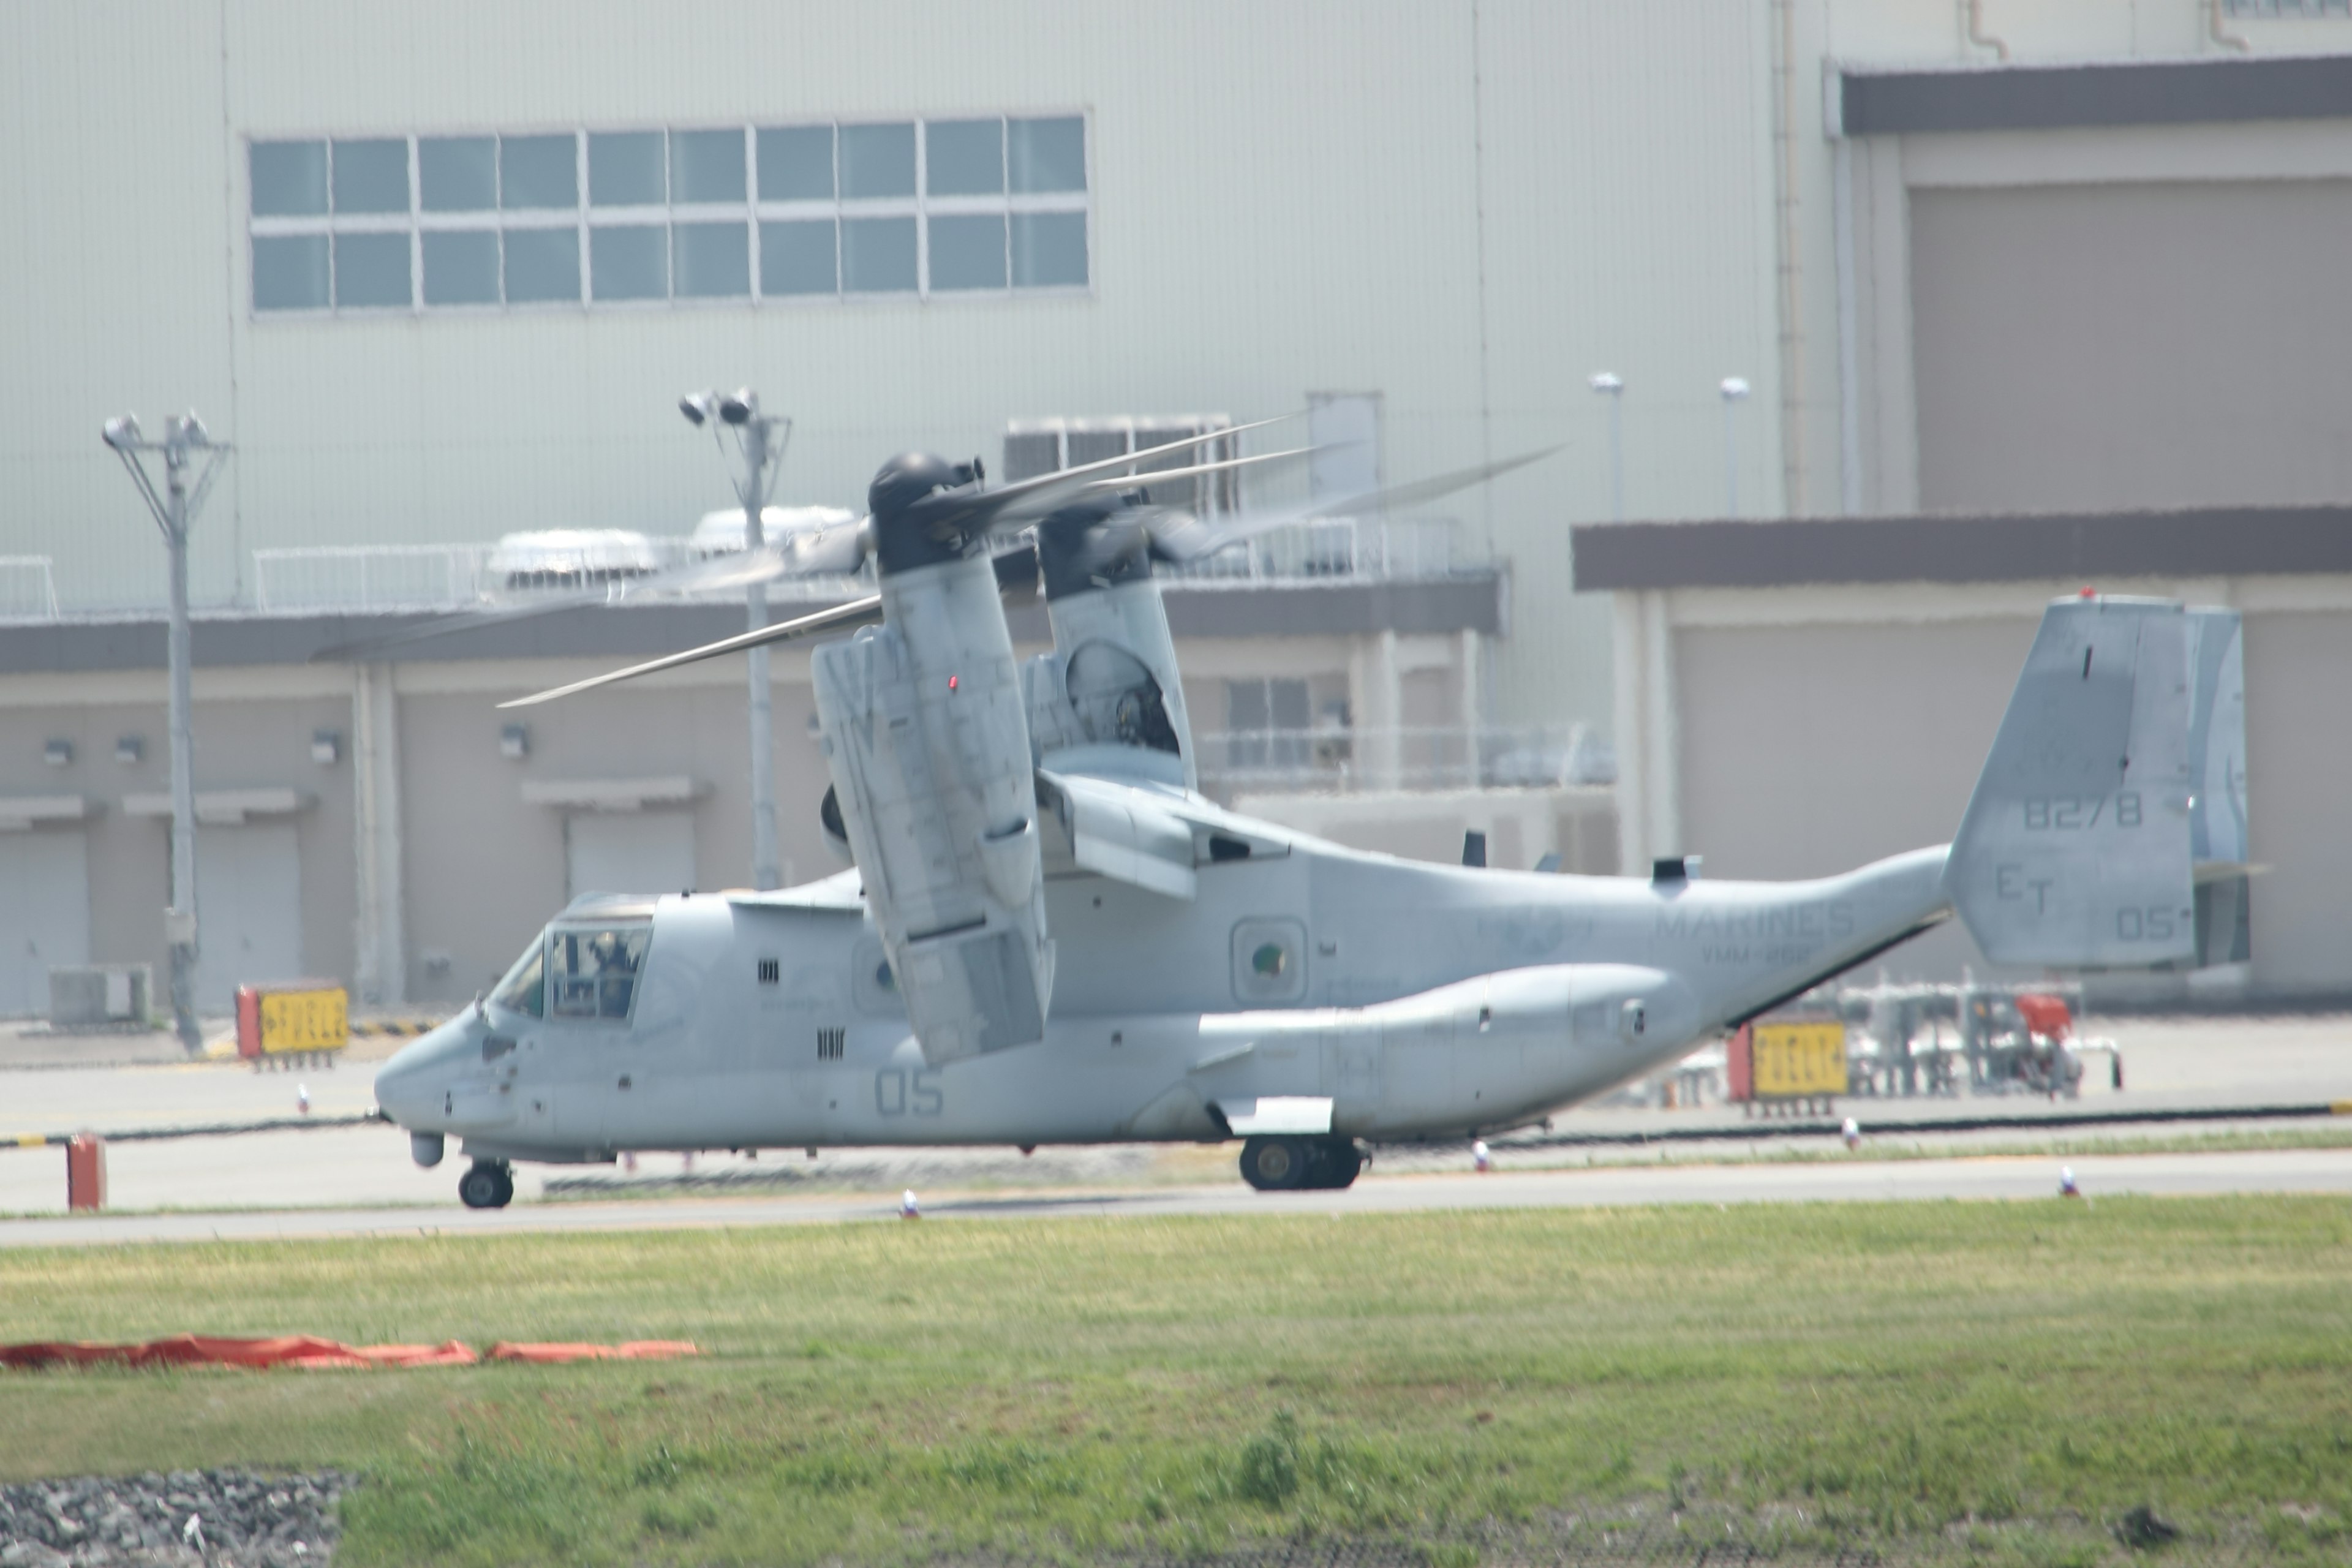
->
[1910,179,2352,513]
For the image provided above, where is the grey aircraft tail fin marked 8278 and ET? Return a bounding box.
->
[1945,597,2246,968]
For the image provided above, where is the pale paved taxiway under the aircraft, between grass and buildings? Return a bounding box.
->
[0,1016,2352,1243]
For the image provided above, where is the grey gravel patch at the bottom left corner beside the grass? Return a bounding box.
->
[0,1469,353,1568]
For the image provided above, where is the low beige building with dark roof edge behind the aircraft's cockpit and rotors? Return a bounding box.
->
[0,569,1524,1016]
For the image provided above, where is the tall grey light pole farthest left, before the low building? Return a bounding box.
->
[104,409,228,1053]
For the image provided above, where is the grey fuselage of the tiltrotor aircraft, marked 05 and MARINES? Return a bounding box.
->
[376,827,1948,1161]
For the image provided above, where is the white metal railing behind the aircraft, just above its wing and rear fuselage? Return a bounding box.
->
[1195,724,1616,797]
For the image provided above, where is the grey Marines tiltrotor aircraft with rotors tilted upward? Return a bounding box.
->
[376,430,2246,1206]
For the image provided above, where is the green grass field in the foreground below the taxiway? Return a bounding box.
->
[0,1199,2352,1568]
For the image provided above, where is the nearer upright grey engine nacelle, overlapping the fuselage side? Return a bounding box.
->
[812,555,1054,1065]
